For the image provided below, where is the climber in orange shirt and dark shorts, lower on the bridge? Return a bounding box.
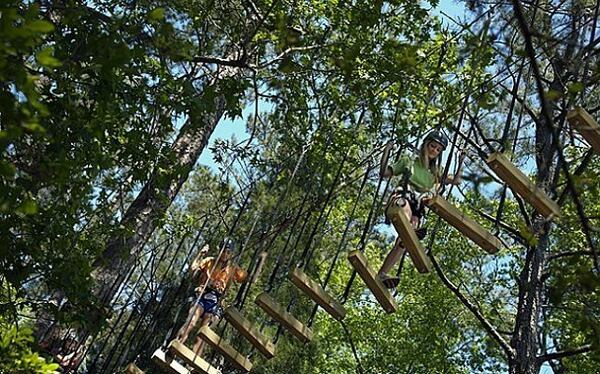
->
[176,239,247,355]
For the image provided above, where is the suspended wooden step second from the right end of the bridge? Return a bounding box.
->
[486,152,560,218]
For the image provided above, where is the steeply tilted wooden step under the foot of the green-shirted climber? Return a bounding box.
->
[386,204,431,273]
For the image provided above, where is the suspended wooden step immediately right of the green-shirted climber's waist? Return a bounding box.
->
[427,195,502,253]
